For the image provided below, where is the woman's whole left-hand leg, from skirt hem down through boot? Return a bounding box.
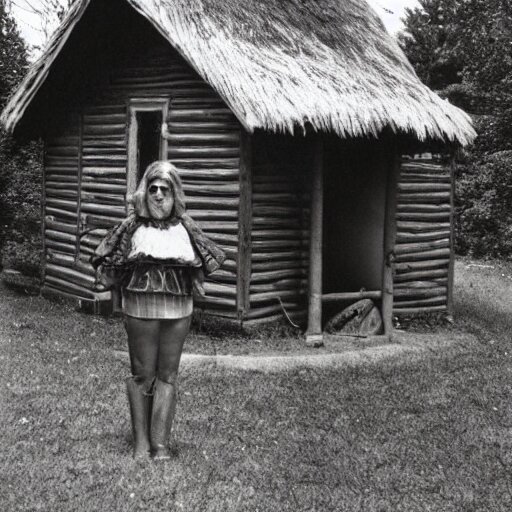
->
[125,316,160,458]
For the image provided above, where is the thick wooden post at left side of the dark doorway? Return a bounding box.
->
[306,134,324,347]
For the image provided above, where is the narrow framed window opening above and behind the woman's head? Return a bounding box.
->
[126,98,169,204]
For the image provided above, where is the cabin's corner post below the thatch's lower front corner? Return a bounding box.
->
[236,127,252,324]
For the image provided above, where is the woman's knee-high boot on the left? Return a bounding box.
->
[126,377,153,459]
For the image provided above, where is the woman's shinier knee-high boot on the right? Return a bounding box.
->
[150,379,177,460]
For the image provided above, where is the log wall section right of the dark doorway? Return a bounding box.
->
[393,158,453,315]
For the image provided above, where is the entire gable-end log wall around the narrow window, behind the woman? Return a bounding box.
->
[45,44,240,318]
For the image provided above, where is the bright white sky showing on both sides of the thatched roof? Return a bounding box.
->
[11,0,418,57]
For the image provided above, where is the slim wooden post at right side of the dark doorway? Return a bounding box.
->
[381,150,400,336]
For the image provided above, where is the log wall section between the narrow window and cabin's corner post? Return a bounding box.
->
[164,63,240,319]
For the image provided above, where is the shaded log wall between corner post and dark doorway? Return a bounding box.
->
[244,136,310,325]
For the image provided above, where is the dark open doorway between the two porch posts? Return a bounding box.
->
[322,139,389,320]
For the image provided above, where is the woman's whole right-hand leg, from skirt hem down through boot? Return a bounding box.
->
[150,317,191,460]
